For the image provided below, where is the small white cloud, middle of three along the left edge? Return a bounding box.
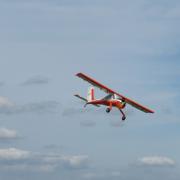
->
[0,128,18,139]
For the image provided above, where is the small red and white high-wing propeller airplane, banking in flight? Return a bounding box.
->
[74,73,154,121]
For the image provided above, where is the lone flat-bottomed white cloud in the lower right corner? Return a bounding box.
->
[138,156,176,166]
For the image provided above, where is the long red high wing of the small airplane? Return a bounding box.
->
[76,73,154,113]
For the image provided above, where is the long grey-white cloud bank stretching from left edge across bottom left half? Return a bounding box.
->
[0,148,89,173]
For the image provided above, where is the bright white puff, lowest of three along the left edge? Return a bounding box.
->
[0,148,30,160]
